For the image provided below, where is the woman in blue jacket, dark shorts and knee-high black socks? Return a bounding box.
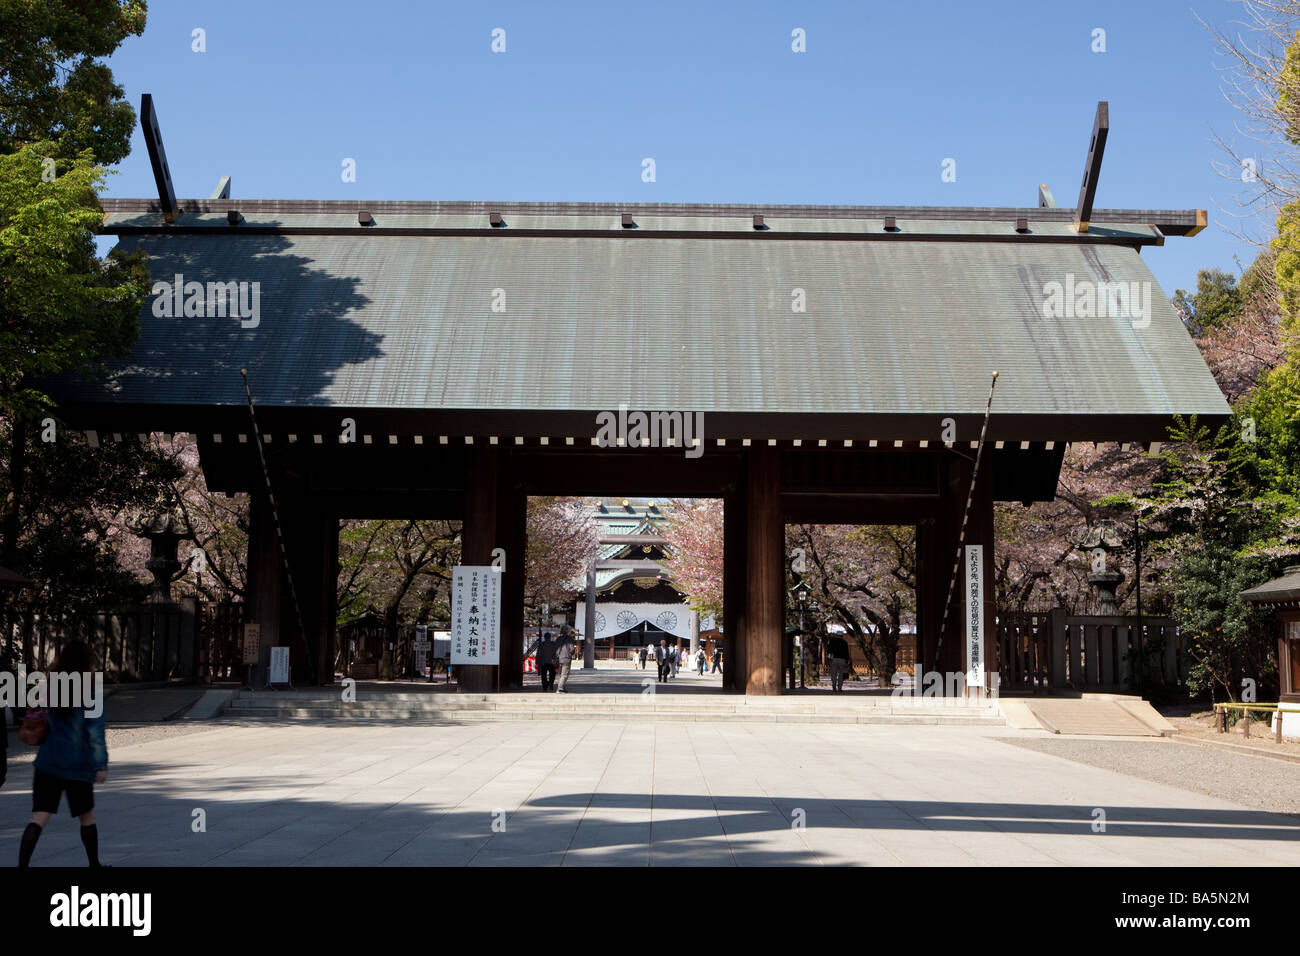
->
[18,641,108,866]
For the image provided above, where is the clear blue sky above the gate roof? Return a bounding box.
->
[108,0,1279,294]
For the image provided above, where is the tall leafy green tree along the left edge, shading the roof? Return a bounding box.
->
[0,0,162,660]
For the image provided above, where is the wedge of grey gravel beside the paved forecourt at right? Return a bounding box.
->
[1002,737,1300,816]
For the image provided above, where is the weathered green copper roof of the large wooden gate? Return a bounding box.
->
[56,200,1229,437]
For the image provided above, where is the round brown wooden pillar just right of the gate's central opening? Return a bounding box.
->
[741,446,785,696]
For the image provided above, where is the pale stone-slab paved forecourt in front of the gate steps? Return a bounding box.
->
[0,719,1300,866]
